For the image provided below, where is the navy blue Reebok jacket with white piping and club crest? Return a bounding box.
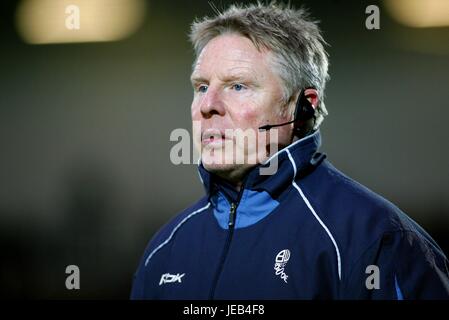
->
[131,131,449,299]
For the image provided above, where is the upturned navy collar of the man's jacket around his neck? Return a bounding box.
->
[198,130,324,198]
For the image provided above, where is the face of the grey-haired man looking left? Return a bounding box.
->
[191,34,292,182]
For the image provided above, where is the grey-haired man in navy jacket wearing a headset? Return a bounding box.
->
[131,4,449,299]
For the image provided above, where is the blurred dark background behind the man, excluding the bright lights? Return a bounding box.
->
[0,0,449,299]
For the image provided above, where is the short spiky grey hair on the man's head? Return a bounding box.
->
[189,2,329,129]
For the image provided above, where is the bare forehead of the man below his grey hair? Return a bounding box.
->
[192,34,271,78]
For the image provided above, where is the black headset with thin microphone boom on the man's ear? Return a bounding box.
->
[259,87,315,137]
